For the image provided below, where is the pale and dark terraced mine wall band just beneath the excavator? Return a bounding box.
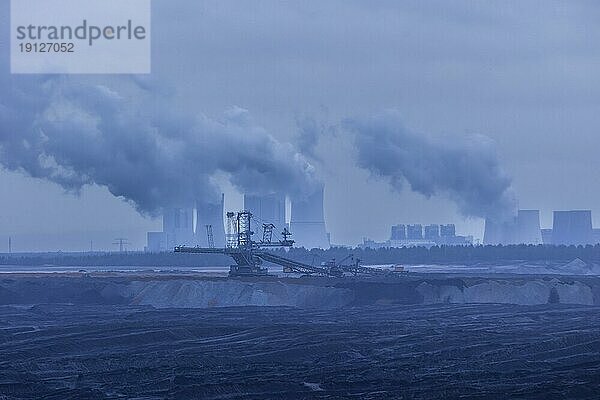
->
[0,274,600,308]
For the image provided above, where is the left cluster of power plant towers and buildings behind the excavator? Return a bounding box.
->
[146,186,330,252]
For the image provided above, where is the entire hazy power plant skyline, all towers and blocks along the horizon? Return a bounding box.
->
[146,189,600,252]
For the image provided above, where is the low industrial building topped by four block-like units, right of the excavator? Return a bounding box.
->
[359,224,473,249]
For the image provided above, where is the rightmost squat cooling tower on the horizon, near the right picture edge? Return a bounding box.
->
[552,210,594,245]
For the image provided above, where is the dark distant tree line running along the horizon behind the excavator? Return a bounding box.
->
[0,245,600,268]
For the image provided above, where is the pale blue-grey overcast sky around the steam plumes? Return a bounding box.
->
[0,0,600,251]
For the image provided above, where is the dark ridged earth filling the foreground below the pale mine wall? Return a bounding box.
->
[0,304,600,400]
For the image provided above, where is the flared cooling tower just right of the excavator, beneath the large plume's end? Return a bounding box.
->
[290,186,329,249]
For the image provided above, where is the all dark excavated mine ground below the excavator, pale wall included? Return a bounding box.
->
[0,274,600,399]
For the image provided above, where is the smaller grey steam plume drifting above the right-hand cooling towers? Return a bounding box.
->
[345,111,516,220]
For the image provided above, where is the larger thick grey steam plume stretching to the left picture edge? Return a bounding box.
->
[0,76,315,214]
